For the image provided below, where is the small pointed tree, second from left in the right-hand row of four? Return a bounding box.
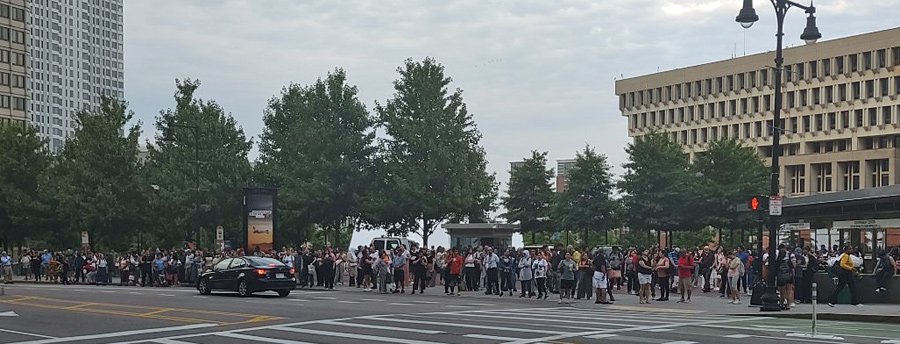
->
[553,146,620,244]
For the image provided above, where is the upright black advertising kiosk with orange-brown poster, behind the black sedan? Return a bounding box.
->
[244,188,277,255]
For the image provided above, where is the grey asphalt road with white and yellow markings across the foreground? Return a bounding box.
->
[0,284,900,344]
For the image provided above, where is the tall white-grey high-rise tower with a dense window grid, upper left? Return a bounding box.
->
[27,0,125,151]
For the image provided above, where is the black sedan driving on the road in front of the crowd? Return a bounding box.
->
[197,257,297,296]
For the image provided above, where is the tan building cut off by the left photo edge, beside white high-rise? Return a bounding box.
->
[0,0,28,125]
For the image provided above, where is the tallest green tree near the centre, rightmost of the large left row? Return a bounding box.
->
[370,58,497,245]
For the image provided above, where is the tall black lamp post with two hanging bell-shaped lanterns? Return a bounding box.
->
[735,0,822,312]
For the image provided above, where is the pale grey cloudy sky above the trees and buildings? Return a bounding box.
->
[124,0,900,244]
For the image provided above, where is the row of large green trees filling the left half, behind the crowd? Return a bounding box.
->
[0,58,497,250]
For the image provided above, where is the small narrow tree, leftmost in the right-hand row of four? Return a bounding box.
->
[503,151,554,244]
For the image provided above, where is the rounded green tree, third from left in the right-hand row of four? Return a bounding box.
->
[619,133,694,236]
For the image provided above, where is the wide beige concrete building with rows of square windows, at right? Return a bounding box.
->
[616,28,900,196]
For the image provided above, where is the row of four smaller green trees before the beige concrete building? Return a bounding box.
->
[503,133,768,250]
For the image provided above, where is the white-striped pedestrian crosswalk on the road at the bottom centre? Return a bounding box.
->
[110,307,772,344]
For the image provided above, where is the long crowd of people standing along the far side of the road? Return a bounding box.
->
[0,241,900,309]
